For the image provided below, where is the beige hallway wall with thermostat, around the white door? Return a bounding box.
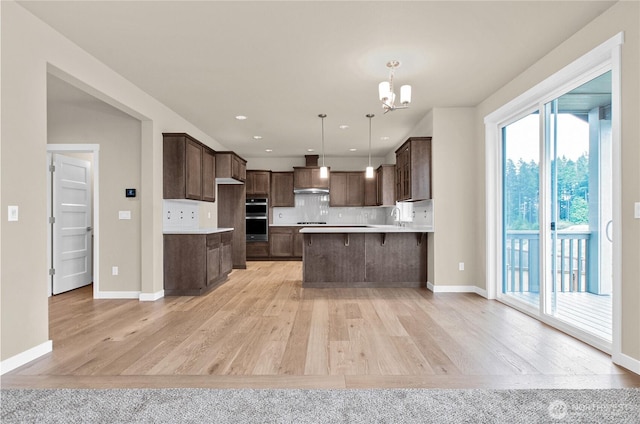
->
[47,76,144,293]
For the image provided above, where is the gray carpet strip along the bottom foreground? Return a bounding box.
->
[0,389,640,424]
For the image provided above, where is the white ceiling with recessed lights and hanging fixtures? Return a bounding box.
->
[19,1,614,158]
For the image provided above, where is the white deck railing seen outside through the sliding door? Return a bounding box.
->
[503,230,591,293]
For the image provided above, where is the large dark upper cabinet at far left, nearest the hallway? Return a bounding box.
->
[163,133,215,202]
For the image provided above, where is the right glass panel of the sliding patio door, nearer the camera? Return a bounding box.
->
[543,72,613,342]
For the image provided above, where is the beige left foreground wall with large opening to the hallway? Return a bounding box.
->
[0,1,229,364]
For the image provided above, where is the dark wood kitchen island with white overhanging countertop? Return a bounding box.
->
[300,225,433,287]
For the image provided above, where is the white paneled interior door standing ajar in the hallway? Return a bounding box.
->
[52,154,93,294]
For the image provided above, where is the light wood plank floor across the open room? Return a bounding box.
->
[1,262,640,388]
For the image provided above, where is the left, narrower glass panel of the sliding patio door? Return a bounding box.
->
[502,111,540,308]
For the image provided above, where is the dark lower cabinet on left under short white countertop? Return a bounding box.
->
[164,231,233,296]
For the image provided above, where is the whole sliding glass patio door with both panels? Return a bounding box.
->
[502,72,613,343]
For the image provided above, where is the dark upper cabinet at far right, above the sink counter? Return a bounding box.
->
[396,137,431,201]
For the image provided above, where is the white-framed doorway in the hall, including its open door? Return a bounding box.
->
[47,144,100,297]
